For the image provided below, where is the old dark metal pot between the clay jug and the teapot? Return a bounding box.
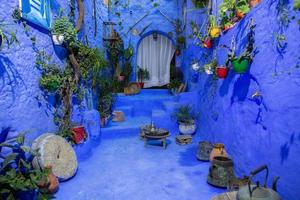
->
[207,156,235,188]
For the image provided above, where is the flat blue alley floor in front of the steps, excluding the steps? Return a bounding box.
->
[56,132,223,200]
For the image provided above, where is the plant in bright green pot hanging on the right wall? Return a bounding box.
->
[223,19,256,74]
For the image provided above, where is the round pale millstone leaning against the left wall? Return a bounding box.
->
[32,133,78,181]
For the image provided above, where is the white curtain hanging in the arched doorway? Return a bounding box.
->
[137,34,175,88]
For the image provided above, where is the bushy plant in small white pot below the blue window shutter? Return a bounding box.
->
[51,17,77,45]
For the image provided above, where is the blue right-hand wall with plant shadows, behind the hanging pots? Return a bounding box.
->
[185,0,300,200]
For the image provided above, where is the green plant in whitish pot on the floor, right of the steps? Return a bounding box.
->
[173,104,198,135]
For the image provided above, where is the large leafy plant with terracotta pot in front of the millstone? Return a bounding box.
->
[0,134,58,199]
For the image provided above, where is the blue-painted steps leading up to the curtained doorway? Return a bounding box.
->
[101,89,196,134]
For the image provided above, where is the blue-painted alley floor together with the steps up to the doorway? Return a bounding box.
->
[56,90,224,200]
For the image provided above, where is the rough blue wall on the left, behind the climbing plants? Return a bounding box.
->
[0,0,107,143]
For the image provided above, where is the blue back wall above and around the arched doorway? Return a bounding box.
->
[109,0,183,81]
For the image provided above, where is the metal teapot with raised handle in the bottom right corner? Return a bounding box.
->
[237,165,281,200]
